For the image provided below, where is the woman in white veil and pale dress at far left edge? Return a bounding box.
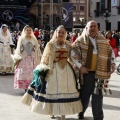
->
[0,24,13,73]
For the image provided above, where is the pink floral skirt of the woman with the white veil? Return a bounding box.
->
[14,52,36,89]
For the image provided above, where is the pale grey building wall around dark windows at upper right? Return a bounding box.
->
[90,0,120,31]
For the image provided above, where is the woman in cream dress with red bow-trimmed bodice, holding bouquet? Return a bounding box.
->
[22,26,82,120]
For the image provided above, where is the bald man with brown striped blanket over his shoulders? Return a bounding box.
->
[71,20,115,120]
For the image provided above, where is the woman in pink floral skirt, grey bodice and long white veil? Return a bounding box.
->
[12,25,41,91]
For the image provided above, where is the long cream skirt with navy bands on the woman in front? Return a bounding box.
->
[22,63,82,115]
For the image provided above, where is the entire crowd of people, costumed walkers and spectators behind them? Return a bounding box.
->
[0,20,120,120]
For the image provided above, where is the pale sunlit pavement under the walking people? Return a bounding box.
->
[0,73,120,120]
